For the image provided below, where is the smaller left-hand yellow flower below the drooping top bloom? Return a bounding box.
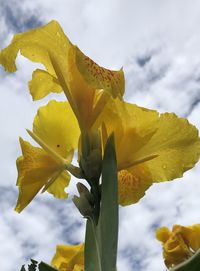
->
[16,101,80,212]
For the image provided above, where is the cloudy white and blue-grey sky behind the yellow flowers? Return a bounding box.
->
[0,0,200,271]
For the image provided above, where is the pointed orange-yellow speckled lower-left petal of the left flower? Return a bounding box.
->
[15,138,59,212]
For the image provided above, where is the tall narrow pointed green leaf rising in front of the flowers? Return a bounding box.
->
[98,135,118,271]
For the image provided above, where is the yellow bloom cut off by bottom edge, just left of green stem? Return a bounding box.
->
[51,244,84,271]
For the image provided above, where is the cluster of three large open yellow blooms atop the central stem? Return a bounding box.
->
[0,21,200,212]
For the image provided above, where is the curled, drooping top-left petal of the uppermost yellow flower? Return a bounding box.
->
[0,21,72,74]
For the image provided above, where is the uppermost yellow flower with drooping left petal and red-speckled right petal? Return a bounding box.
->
[0,21,124,129]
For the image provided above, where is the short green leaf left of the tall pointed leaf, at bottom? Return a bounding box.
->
[84,219,102,271]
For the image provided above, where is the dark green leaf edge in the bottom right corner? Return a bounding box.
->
[170,249,200,271]
